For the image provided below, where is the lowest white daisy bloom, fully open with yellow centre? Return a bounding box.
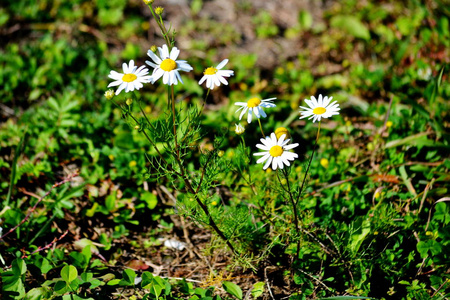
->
[253,132,298,170]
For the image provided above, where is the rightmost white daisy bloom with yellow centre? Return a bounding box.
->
[300,95,340,123]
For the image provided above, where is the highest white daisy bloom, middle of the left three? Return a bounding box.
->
[145,45,192,85]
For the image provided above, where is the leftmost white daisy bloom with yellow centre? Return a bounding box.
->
[108,60,152,95]
